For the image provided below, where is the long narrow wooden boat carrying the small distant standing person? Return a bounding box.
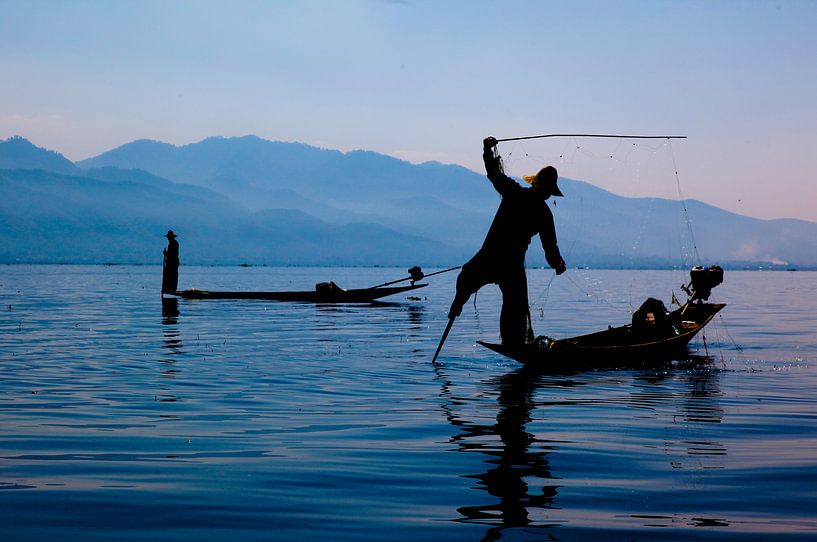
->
[170,284,428,303]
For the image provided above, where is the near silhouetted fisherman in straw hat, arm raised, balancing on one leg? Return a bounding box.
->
[446,137,567,346]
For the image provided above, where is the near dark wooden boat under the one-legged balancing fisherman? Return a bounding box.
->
[477,301,726,369]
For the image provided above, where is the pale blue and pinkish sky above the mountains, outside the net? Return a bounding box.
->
[0,0,817,221]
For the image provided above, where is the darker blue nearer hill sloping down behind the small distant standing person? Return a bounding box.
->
[0,170,460,265]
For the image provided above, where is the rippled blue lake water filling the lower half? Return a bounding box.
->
[0,266,817,541]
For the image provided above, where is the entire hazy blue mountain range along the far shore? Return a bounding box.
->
[0,136,817,268]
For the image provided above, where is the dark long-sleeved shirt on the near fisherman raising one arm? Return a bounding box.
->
[480,149,562,269]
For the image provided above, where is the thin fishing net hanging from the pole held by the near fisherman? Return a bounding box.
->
[497,136,700,314]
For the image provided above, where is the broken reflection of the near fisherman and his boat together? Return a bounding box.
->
[438,367,729,540]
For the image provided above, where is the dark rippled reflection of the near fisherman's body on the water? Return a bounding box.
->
[449,368,558,540]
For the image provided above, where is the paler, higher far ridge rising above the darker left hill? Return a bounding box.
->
[78,136,495,212]
